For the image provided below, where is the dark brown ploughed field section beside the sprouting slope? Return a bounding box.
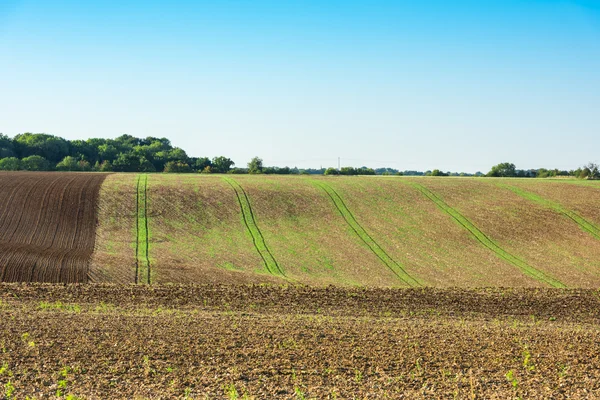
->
[0,172,106,282]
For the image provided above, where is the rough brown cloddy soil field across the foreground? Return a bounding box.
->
[0,284,600,399]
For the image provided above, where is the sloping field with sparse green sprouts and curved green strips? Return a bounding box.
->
[92,174,600,287]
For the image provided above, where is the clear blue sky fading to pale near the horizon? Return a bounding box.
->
[0,0,600,172]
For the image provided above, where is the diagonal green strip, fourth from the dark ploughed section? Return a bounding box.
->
[409,182,566,288]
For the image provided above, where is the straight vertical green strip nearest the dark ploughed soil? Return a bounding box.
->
[135,174,152,284]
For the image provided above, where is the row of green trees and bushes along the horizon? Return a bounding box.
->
[0,133,600,179]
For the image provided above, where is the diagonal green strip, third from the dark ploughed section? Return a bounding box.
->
[313,181,421,286]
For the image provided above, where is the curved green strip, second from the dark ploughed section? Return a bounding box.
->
[223,177,285,277]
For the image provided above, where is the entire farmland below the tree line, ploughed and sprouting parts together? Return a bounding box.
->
[0,172,600,399]
